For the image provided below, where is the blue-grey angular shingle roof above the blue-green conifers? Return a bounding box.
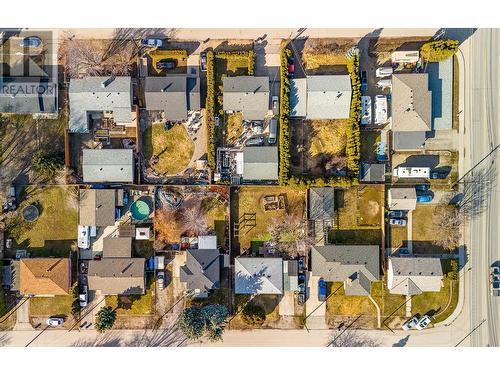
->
[180,249,220,291]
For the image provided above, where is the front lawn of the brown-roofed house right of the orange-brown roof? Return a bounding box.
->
[106,275,155,315]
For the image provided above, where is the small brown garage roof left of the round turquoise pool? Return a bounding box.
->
[79,189,116,227]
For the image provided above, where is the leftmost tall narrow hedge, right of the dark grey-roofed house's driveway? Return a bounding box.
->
[205,51,217,170]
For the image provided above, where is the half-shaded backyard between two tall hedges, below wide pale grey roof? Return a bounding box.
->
[290,120,348,177]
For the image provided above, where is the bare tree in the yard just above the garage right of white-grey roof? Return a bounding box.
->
[267,214,314,256]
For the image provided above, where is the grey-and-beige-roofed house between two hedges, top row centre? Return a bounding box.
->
[223,76,269,121]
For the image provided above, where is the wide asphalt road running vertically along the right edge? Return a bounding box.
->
[465,29,500,346]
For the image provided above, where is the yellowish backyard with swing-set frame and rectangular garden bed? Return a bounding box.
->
[231,186,306,253]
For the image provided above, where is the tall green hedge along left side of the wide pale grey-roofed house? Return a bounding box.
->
[279,47,292,185]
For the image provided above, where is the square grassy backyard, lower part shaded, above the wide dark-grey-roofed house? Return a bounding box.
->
[329,185,384,245]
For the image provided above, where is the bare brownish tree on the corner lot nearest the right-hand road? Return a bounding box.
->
[432,205,464,250]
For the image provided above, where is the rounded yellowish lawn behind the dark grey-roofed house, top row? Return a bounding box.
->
[142,123,194,174]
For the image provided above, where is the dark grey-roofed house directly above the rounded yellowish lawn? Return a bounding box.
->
[144,74,200,121]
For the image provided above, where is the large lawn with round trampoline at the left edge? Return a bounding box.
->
[6,187,78,257]
